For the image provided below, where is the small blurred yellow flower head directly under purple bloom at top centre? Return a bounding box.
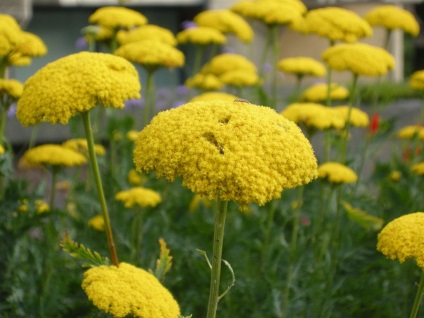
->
[177,26,227,45]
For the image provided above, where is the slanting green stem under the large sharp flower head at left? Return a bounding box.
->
[81,112,119,266]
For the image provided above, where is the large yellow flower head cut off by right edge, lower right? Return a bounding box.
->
[377,212,424,269]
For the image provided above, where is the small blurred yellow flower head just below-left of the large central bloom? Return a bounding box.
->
[115,187,162,208]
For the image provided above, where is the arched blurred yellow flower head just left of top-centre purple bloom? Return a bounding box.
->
[117,24,177,46]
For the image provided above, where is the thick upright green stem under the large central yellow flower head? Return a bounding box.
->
[207,198,228,318]
